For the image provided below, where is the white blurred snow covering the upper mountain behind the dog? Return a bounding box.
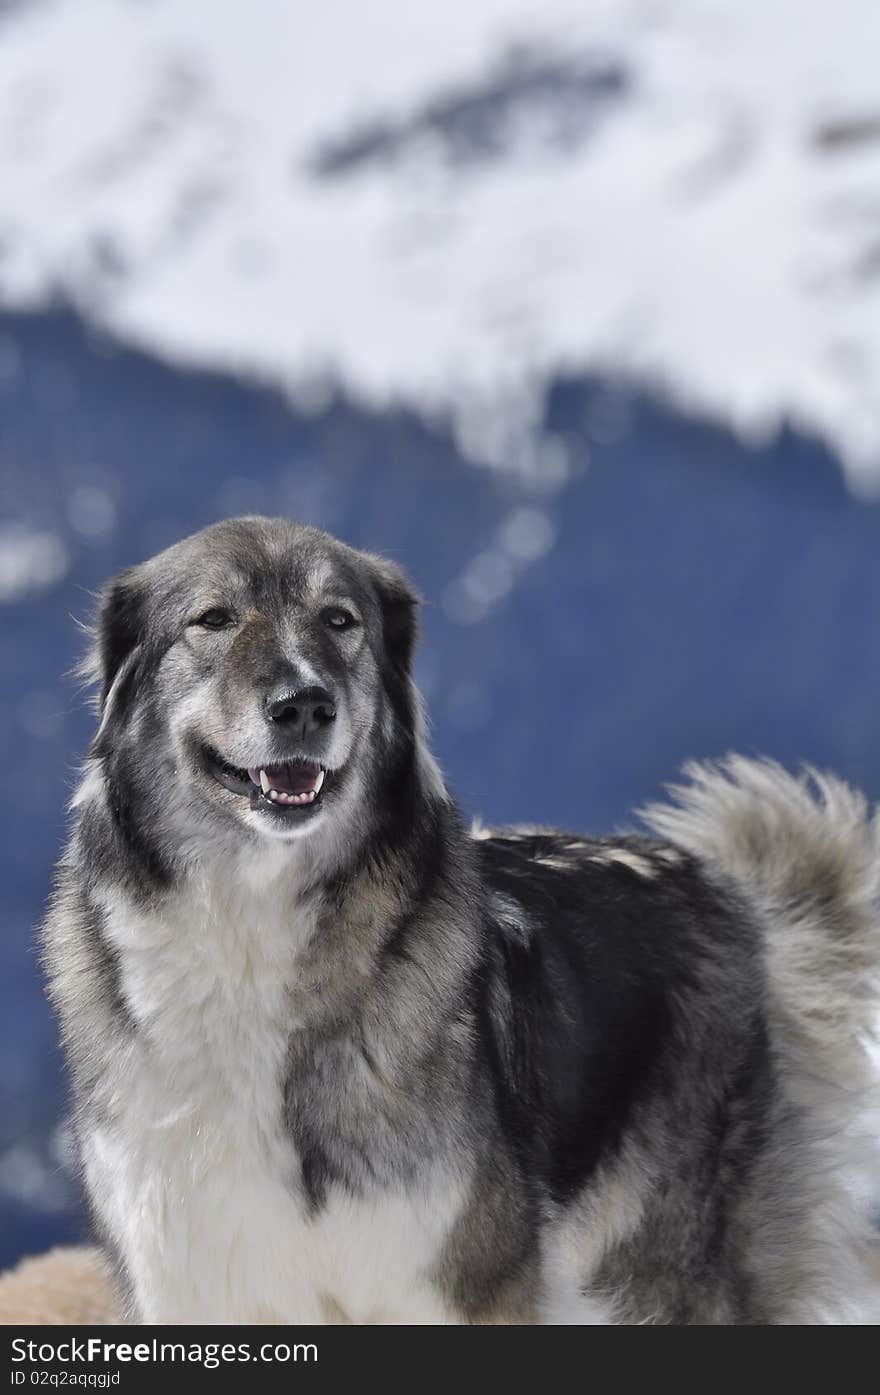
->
[0,0,880,490]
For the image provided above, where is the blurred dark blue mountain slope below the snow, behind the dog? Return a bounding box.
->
[0,310,880,1264]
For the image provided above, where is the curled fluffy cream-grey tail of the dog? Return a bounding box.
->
[643,756,880,1088]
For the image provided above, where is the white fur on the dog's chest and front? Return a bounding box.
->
[82,859,462,1322]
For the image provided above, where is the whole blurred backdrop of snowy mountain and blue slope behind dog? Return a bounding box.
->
[0,0,880,1265]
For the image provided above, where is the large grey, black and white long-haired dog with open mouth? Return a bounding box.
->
[42,518,880,1324]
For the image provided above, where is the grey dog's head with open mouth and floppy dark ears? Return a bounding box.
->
[85,518,418,838]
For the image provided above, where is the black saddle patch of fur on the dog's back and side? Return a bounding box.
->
[477,834,764,1201]
